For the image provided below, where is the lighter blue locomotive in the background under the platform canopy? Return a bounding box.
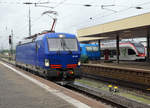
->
[80,44,100,60]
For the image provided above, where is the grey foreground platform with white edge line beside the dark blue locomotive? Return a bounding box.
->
[0,61,106,108]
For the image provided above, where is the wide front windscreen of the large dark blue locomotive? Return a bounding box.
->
[48,38,78,51]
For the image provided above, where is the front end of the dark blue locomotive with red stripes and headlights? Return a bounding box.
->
[45,34,80,80]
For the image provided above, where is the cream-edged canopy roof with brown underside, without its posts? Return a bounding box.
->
[77,13,150,39]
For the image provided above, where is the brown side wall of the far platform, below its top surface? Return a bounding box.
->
[81,64,150,91]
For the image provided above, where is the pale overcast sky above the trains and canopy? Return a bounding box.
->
[0,0,150,48]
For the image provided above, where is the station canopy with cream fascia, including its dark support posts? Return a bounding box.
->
[77,13,150,63]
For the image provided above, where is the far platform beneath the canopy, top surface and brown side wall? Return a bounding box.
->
[81,61,150,90]
